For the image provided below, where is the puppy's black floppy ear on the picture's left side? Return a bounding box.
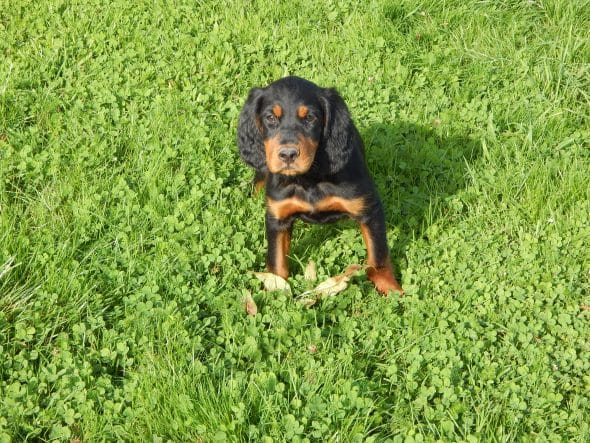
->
[238,88,267,172]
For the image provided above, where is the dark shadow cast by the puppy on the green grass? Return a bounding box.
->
[293,122,481,276]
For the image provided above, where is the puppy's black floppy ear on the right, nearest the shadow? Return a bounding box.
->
[320,89,360,174]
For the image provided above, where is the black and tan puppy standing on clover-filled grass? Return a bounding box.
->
[238,77,403,294]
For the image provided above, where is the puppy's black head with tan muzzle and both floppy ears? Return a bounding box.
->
[238,77,357,176]
